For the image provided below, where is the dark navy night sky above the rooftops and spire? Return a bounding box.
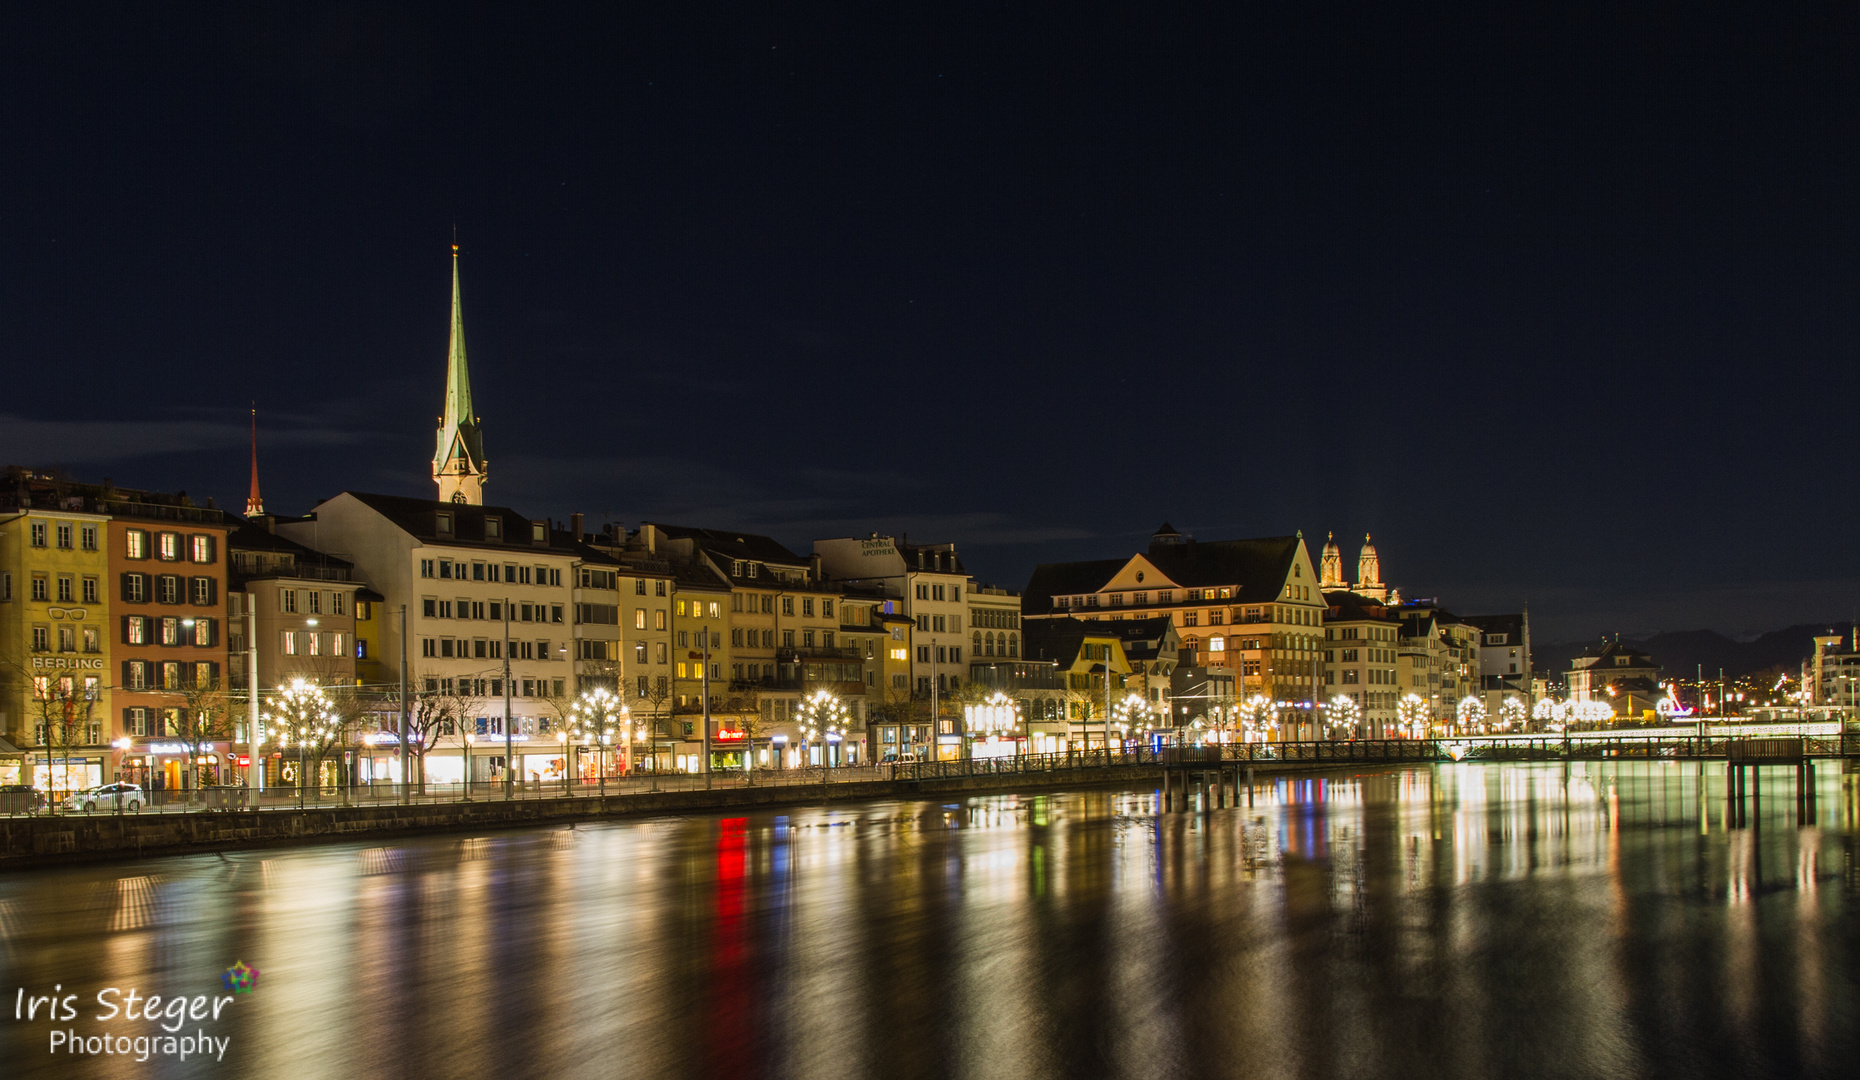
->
[0,4,1860,639]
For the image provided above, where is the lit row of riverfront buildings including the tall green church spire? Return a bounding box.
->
[0,251,1535,786]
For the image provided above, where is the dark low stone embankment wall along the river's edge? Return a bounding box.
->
[0,762,1362,872]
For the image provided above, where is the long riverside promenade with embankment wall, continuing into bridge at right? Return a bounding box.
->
[0,731,1860,870]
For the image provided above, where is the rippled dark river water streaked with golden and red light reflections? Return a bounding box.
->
[0,764,1860,1080]
